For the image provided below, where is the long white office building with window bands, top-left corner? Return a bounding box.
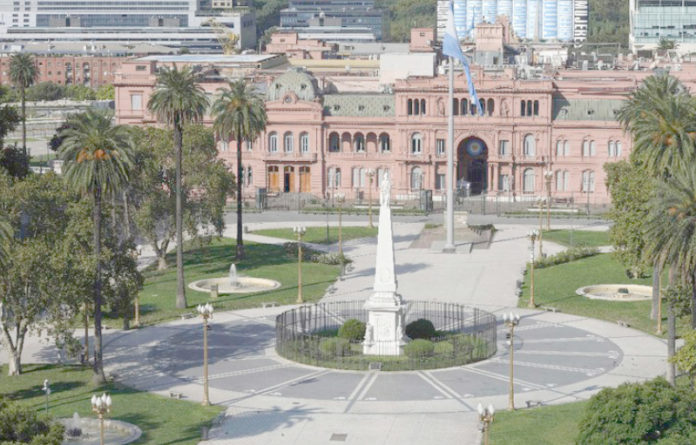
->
[0,0,256,49]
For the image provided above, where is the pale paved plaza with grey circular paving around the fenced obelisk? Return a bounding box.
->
[9,222,666,445]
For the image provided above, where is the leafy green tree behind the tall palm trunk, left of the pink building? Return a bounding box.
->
[129,125,234,269]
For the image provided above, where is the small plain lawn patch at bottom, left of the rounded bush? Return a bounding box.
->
[490,402,587,445]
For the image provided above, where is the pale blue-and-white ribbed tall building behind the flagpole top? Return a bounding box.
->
[437,0,584,42]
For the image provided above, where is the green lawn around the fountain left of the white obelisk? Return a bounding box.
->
[130,238,340,324]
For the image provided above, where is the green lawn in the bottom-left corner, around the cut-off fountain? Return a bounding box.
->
[0,365,224,445]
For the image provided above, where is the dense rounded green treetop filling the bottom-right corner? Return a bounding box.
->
[575,377,696,445]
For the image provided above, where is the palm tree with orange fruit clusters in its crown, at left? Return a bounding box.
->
[59,110,133,381]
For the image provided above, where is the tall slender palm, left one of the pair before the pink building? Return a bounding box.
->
[147,65,208,309]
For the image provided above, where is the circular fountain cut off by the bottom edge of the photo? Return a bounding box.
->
[58,413,143,445]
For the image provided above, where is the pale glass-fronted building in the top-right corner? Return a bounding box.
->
[629,0,696,52]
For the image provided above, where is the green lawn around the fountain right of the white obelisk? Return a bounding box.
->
[519,253,687,335]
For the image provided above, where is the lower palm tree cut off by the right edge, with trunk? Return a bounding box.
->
[646,166,696,383]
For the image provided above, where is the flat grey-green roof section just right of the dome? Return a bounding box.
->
[324,94,396,117]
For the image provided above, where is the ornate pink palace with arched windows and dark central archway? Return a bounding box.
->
[116,53,696,204]
